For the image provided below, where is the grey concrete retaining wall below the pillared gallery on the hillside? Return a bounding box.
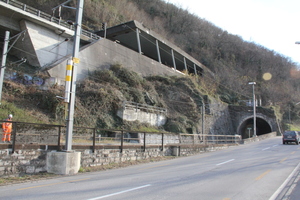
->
[48,38,183,84]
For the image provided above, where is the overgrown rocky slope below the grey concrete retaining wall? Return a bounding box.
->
[1,62,213,133]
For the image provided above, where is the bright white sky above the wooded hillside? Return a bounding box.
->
[165,0,300,65]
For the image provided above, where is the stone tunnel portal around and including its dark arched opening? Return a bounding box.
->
[228,106,279,139]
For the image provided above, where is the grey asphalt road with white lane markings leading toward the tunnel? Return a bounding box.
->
[0,137,300,200]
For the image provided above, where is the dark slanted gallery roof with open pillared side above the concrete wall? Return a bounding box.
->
[96,20,207,75]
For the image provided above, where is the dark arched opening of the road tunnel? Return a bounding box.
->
[238,117,272,139]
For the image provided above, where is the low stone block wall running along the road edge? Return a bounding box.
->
[0,144,236,177]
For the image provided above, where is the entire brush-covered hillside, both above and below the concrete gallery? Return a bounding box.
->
[4,0,300,128]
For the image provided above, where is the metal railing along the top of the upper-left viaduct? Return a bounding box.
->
[0,0,100,40]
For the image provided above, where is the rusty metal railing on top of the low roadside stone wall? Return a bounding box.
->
[0,121,241,153]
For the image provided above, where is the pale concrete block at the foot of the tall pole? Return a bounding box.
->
[46,152,81,175]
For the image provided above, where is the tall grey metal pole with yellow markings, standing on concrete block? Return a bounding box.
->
[65,0,84,151]
